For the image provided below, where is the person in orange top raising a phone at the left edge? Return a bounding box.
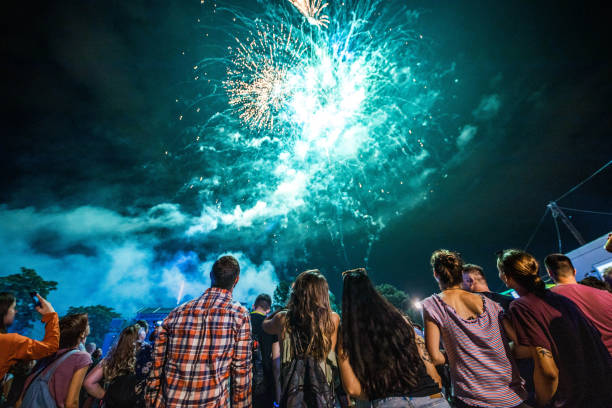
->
[0,292,60,382]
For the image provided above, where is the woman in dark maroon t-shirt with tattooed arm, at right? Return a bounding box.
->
[497,249,612,408]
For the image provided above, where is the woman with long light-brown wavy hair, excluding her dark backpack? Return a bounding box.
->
[262,270,340,406]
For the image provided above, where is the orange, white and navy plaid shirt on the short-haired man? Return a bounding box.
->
[145,288,251,408]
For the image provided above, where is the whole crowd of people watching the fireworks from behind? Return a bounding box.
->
[0,239,612,408]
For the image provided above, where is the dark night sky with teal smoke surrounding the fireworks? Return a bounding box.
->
[0,0,612,313]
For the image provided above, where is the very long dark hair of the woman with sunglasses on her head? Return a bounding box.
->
[340,268,423,398]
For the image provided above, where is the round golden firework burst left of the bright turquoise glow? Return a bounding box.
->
[224,25,305,129]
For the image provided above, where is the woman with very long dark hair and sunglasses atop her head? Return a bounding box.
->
[337,268,449,408]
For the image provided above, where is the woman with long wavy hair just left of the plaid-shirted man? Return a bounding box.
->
[84,325,144,407]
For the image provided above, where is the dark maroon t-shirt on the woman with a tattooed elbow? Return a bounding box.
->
[508,291,612,408]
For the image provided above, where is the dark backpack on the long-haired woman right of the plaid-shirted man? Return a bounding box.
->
[280,356,335,408]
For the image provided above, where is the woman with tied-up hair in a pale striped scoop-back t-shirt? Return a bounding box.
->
[422,249,526,408]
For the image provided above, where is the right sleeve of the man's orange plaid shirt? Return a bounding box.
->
[231,313,252,408]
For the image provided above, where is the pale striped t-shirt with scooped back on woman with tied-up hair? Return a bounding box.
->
[423,295,524,408]
